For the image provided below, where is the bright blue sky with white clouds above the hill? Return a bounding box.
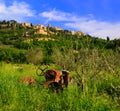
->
[0,0,120,39]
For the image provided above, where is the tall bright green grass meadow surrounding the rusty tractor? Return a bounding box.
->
[0,62,120,111]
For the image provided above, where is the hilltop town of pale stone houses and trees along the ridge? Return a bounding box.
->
[0,20,84,36]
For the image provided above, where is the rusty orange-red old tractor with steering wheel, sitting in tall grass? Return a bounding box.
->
[36,66,69,91]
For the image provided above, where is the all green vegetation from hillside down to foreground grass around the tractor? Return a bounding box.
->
[0,20,120,111]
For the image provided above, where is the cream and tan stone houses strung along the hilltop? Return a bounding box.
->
[21,22,84,36]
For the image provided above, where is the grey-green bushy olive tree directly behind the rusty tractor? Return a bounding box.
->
[52,48,75,70]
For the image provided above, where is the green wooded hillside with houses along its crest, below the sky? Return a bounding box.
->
[0,20,120,64]
